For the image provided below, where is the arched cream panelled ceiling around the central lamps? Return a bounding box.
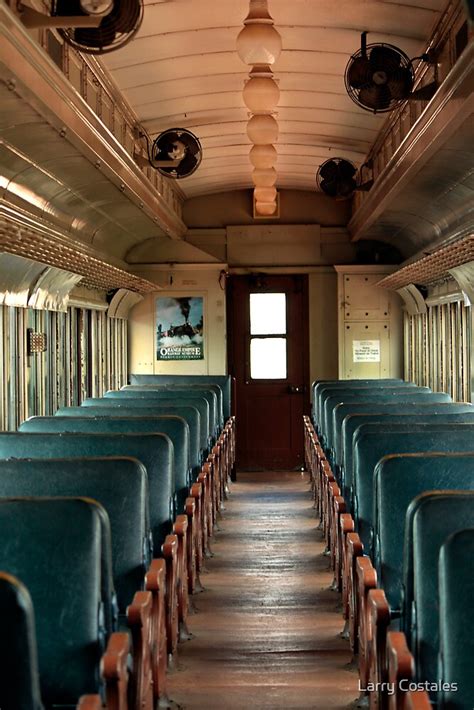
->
[103,0,446,197]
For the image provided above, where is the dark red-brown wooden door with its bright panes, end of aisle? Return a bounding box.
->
[228,274,309,470]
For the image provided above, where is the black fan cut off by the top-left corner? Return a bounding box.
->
[53,0,143,54]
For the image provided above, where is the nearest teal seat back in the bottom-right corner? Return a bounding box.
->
[438,527,474,710]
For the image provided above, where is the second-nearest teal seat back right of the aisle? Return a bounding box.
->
[402,490,474,683]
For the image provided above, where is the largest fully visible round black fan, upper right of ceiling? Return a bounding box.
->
[344,43,415,113]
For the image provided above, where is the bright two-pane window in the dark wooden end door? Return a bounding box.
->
[250,293,288,380]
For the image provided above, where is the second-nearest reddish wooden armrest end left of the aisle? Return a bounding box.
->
[101,631,130,710]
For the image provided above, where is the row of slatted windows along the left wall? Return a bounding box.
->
[0,305,128,430]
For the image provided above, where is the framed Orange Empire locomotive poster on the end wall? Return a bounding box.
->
[156,296,204,360]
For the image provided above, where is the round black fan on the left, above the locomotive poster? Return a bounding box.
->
[149,128,202,180]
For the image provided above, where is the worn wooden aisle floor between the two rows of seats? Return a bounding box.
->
[169,473,358,710]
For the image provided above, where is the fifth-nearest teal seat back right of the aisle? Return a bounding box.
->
[336,402,474,501]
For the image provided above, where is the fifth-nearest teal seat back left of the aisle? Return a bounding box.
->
[18,414,190,512]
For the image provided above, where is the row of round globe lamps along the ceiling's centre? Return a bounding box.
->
[237,0,281,216]
